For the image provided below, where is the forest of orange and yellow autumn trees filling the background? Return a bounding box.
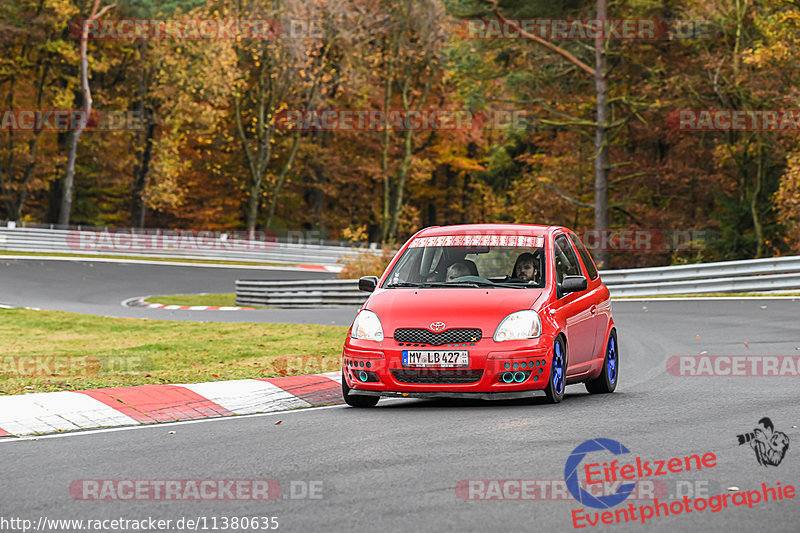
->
[0,0,800,265]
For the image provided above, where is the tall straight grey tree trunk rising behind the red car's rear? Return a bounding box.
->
[594,0,609,268]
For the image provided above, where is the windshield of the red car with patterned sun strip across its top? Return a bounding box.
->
[383,235,545,289]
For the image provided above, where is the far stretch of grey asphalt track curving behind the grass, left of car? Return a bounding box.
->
[0,258,358,326]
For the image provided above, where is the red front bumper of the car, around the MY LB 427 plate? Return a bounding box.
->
[342,336,552,399]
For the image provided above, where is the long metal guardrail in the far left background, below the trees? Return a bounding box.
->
[0,227,377,266]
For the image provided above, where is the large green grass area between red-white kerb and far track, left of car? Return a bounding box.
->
[0,309,347,394]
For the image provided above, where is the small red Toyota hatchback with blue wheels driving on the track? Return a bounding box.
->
[342,224,619,407]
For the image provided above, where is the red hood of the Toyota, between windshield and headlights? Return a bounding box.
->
[364,288,544,337]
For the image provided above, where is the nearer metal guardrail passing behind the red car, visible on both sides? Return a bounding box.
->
[236,256,800,307]
